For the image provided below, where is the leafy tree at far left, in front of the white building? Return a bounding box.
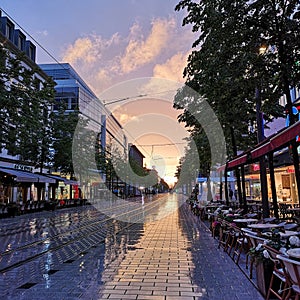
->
[0,45,54,168]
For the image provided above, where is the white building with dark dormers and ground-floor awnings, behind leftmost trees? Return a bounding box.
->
[0,11,56,204]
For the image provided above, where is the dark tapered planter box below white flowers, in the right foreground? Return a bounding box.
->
[256,261,274,296]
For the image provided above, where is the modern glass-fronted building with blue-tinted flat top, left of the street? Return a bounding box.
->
[40,63,128,199]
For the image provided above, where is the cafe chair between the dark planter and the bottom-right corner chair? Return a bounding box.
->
[263,244,290,300]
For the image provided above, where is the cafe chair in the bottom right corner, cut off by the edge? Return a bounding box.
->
[276,254,300,300]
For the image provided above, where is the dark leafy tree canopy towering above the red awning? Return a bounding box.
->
[174,0,300,173]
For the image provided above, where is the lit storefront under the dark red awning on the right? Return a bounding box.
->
[219,121,300,217]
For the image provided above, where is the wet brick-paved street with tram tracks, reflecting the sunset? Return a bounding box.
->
[0,194,263,300]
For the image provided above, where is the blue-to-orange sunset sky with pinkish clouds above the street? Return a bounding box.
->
[0,0,196,183]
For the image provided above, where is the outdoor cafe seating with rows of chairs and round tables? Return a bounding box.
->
[190,198,300,299]
